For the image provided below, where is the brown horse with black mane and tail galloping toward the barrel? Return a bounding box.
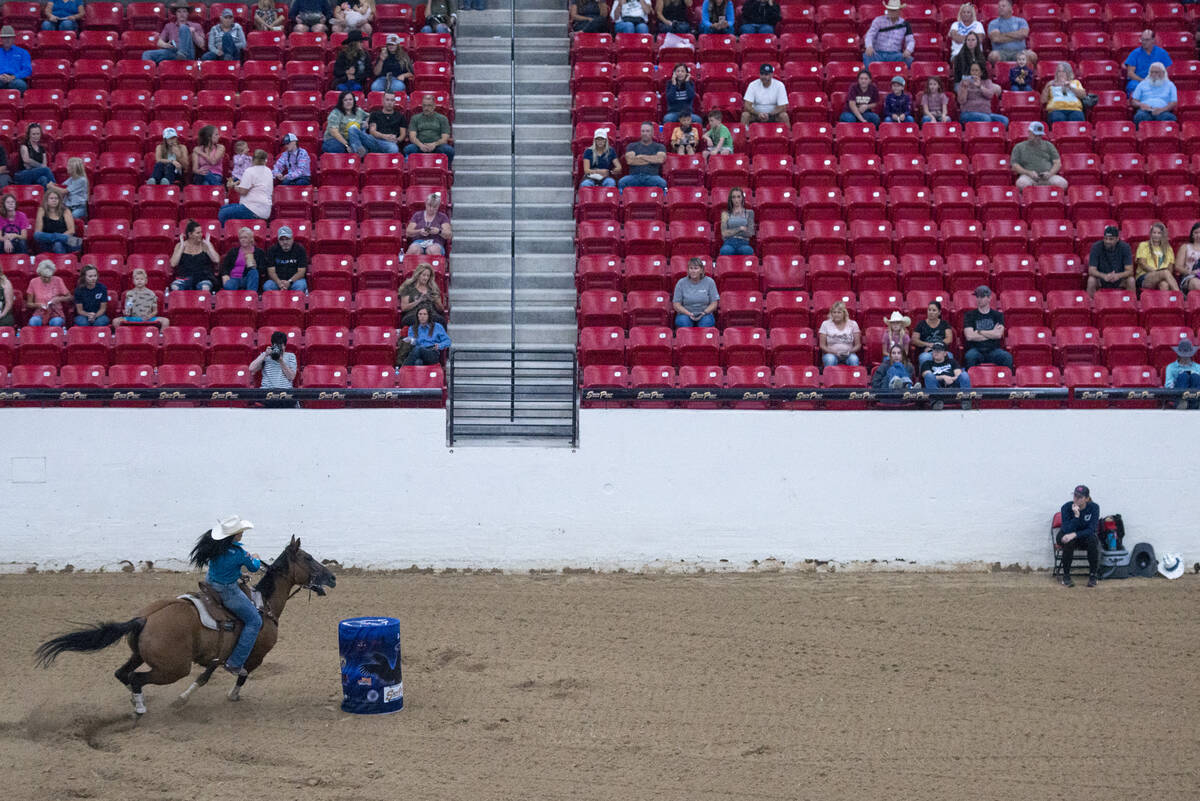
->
[35,537,337,715]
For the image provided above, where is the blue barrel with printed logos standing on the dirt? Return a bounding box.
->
[337,618,404,715]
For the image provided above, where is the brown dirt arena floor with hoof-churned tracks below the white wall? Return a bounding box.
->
[0,572,1200,801]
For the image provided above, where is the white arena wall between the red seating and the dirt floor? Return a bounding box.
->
[0,409,1200,571]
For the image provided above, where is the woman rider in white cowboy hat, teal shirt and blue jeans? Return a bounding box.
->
[191,514,263,676]
